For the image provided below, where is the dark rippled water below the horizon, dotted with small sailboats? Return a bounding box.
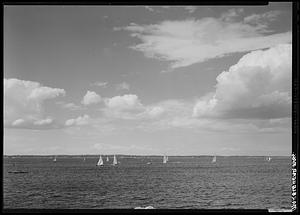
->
[3,156,291,209]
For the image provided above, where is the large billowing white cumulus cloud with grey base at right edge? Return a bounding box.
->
[193,44,292,119]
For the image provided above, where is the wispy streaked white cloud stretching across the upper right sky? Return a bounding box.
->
[115,10,292,69]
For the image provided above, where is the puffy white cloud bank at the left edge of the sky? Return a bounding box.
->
[4,79,65,127]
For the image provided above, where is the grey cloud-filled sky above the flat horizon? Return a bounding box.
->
[3,2,292,156]
